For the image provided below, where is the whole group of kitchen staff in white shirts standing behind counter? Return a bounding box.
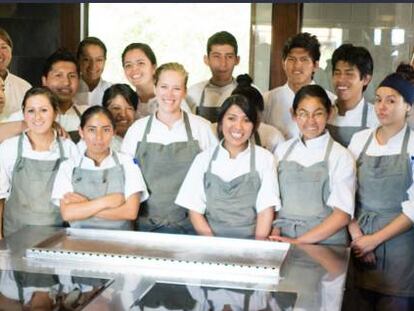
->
[0,29,414,310]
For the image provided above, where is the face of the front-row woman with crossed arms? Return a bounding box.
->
[79,113,114,159]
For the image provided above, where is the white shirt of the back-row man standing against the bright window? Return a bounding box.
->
[187,79,237,113]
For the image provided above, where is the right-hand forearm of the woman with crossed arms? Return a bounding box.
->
[96,193,140,220]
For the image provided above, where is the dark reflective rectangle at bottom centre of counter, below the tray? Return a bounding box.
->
[130,282,297,311]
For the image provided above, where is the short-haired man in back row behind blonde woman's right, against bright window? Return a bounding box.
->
[186,31,240,123]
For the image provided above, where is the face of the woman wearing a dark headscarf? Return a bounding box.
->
[374,86,411,127]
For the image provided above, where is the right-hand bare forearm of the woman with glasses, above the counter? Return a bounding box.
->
[298,208,351,244]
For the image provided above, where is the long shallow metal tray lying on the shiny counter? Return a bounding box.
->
[26,229,289,283]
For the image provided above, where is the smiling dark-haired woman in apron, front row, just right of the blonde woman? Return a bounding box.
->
[175,95,280,239]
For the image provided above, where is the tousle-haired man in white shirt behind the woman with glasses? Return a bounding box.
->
[263,32,335,139]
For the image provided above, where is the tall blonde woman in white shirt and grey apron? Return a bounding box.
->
[121,63,216,233]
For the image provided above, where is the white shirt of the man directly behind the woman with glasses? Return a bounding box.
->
[263,81,336,139]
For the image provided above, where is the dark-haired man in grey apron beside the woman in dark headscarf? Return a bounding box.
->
[328,44,378,147]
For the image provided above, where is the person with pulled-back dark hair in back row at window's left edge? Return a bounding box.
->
[76,37,111,106]
